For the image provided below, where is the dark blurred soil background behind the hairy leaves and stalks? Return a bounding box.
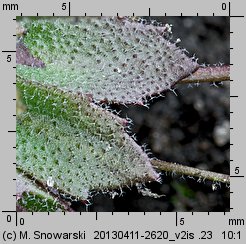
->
[72,17,230,212]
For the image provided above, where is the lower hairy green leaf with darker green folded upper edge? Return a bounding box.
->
[16,80,158,199]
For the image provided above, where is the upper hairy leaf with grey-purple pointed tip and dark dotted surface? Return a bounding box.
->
[17,17,198,104]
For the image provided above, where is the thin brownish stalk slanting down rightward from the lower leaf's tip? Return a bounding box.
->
[151,159,230,184]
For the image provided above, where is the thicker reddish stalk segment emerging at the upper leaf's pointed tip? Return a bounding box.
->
[178,65,230,84]
